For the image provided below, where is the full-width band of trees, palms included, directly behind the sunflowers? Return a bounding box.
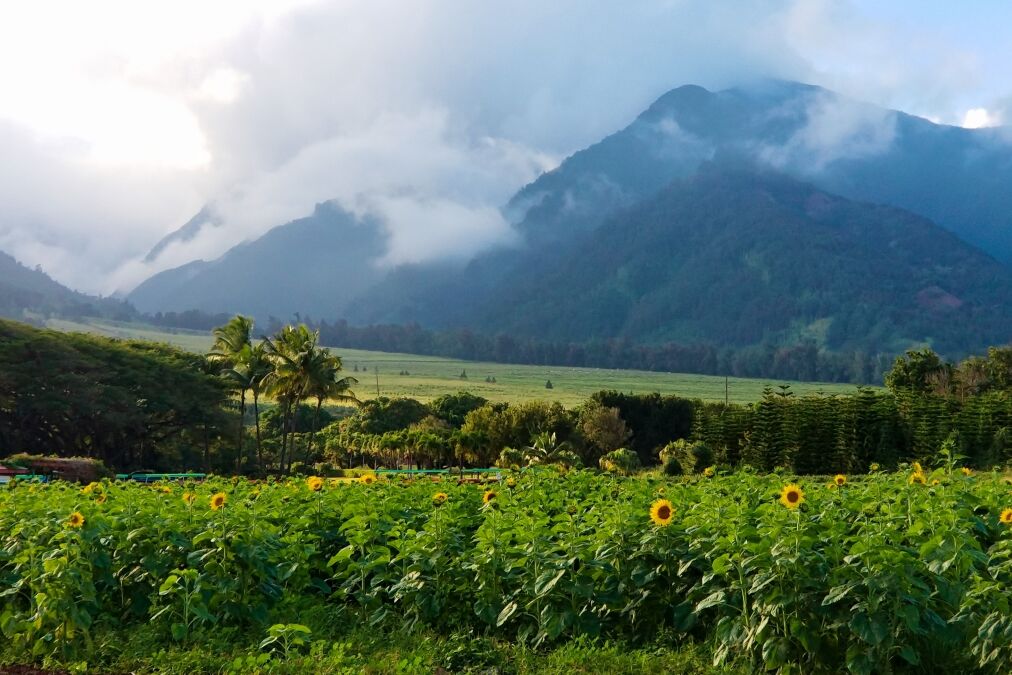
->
[0,316,1012,476]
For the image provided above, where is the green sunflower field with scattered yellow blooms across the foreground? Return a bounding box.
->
[0,466,1012,673]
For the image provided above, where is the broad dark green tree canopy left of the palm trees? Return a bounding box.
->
[0,321,236,469]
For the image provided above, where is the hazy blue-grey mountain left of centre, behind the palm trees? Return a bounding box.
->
[128,202,387,319]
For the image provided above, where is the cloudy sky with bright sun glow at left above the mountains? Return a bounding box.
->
[0,0,1012,294]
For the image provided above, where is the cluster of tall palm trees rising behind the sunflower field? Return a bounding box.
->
[207,315,358,474]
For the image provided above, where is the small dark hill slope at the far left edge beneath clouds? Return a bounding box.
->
[0,251,136,322]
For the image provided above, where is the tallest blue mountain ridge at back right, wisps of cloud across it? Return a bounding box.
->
[508,81,1012,263]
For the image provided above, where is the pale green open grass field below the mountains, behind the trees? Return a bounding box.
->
[49,320,870,407]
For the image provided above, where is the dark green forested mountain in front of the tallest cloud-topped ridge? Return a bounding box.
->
[431,164,1012,353]
